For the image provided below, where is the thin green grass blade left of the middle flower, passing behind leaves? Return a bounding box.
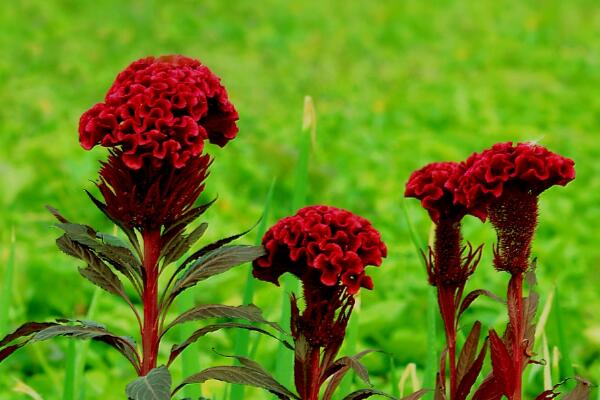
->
[229,179,276,400]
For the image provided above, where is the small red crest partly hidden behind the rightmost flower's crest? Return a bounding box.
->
[404,162,476,224]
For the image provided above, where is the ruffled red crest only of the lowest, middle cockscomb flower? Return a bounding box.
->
[253,206,387,294]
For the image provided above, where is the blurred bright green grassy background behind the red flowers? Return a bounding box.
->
[0,0,600,400]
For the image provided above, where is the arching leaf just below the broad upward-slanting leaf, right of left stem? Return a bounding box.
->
[164,304,283,332]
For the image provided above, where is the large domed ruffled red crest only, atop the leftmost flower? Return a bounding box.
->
[79,55,238,170]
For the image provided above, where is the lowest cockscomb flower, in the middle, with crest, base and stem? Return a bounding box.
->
[253,206,387,400]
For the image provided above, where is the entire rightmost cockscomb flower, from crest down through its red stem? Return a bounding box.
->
[458,142,575,400]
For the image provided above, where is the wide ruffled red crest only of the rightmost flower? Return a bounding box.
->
[458,142,575,216]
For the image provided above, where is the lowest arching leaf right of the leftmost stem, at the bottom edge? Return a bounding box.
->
[173,365,299,399]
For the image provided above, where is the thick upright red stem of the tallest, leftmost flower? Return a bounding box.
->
[140,229,161,376]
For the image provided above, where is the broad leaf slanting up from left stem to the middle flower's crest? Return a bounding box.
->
[171,246,265,299]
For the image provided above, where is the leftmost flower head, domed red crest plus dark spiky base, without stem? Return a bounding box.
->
[79,55,238,231]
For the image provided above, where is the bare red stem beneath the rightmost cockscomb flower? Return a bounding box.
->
[508,273,525,400]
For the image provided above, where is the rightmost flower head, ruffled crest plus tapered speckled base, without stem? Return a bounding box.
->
[459,142,575,274]
